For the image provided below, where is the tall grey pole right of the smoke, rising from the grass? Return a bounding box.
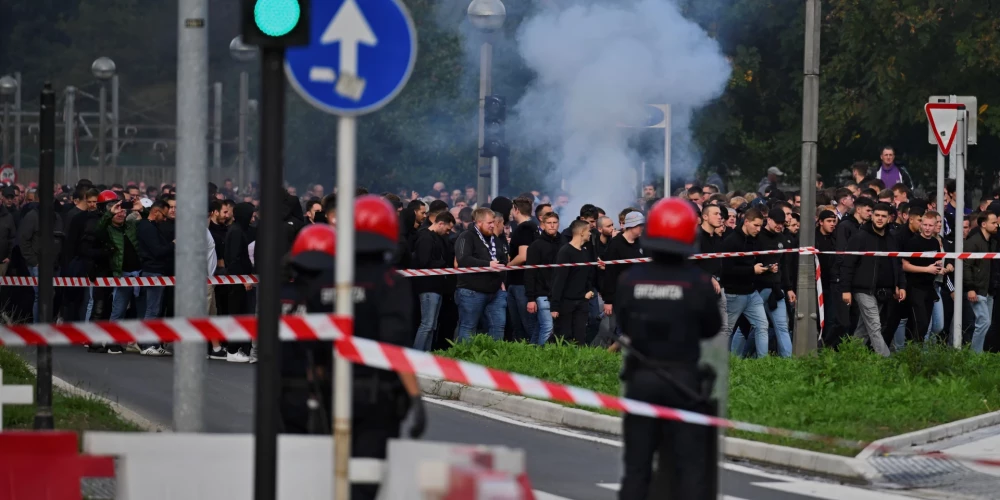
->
[793,0,829,356]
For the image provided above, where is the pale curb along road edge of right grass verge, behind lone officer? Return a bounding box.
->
[419,377,884,483]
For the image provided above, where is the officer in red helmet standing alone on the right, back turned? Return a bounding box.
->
[615,198,722,500]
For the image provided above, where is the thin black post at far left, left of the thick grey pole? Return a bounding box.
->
[33,82,56,429]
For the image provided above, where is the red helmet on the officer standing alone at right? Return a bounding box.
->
[642,198,698,255]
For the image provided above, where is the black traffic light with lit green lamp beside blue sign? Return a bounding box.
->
[243,0,310,48]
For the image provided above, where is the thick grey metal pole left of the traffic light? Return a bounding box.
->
[174,0,208,432]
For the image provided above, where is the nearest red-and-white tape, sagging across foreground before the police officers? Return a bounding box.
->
[0,314,1000,466]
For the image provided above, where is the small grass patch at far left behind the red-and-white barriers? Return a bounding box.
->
[0,347,140,432]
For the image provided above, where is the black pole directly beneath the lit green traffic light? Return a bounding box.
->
[254,48,285,500]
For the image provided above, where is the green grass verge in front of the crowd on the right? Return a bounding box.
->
[439,336,1000,455]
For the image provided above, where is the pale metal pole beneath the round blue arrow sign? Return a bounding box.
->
[333,116,357,500]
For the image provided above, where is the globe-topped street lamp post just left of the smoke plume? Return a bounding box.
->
[466,0,507,207]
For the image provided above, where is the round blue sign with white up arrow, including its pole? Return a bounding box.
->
[285,0,417,500]
